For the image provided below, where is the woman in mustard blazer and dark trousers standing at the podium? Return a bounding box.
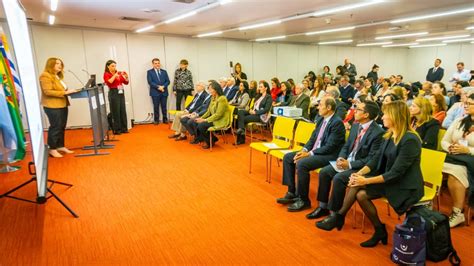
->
[40,57,77,158]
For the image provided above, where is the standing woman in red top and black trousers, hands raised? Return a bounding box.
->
[104,60,128,135]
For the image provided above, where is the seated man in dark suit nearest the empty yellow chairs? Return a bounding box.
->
[277,97,346,212]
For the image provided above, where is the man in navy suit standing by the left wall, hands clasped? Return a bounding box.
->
[146,58,170,125]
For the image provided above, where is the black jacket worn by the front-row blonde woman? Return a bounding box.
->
[367,132,424,214]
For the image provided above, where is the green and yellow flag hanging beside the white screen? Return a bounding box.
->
[0,29,26,161]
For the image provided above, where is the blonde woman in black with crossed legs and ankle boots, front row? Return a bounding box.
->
[316,101,424,247]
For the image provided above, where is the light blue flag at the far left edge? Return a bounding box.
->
[0,80,18,164]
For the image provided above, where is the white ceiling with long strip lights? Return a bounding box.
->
[11,0,474,45]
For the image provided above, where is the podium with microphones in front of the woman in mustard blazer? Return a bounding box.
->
[69,83,114,157]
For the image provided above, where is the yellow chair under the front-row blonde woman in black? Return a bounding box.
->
[362,148,446,231]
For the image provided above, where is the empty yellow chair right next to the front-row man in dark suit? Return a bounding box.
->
[268,121,316,183]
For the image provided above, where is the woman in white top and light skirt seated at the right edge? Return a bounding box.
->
[441,94,474,227]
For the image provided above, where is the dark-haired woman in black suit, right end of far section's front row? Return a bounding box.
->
[236,80,272,145]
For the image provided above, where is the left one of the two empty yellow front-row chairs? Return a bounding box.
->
[249,117,296,182]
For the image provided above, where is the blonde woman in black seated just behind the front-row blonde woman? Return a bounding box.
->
[410,97,441,150]
